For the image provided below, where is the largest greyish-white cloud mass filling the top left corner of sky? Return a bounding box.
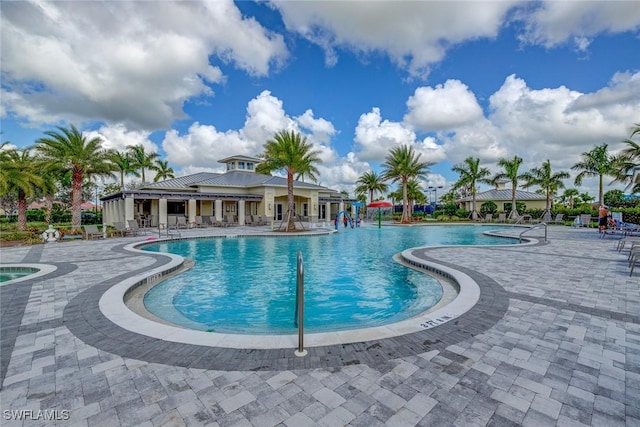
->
[1,0,287,129]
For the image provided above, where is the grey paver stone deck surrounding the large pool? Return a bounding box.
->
[0,226,640,427]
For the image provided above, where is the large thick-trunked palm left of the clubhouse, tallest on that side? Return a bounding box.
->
[35,125,113,230]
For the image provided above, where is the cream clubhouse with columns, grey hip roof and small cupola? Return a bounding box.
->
[100,156,351,226]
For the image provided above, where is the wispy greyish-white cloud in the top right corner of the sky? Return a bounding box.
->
[520,0,640,48]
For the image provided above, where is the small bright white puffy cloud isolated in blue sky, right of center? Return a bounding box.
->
[404,80,482,132]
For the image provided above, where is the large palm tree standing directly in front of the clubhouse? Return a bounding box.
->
[256,130,320,231]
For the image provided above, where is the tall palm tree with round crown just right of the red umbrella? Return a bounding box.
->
[382,145,433,224]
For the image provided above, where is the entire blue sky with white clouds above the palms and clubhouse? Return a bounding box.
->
[0,0,640,201]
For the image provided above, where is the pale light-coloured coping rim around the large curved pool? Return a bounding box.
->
[98,231,537,350]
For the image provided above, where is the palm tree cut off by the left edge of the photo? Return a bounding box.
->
[0,149,44,231]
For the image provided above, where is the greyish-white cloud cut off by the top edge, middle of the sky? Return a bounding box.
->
[272,1,517,75]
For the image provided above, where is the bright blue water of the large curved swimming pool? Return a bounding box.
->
[144,226,513,334]
